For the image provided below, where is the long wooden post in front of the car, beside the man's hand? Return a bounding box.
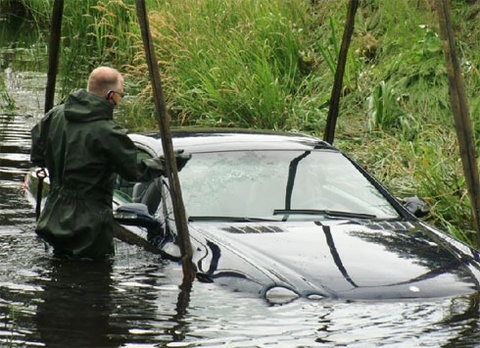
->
[135,0,195,285]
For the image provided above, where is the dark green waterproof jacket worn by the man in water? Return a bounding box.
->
[31,90,163,258]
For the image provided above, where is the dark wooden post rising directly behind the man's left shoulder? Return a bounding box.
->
[45,0,63,113]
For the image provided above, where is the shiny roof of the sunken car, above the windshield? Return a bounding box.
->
[129,129,334,153]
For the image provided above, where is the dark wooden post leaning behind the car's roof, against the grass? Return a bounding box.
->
[323,0,358,144]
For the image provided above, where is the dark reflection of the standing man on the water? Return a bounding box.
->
[35,260,116,347]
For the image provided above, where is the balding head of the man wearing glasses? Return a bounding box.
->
[87,66,123,98]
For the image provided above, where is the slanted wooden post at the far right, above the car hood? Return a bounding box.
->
[436,0,480,247]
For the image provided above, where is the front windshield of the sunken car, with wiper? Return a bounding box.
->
[179,150,398,220]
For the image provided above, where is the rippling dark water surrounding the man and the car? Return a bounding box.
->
[0,70,480,347]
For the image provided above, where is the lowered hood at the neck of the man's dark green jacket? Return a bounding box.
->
[65,89,113,122]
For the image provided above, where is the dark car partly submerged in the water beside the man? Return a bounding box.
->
[26,130,480,302]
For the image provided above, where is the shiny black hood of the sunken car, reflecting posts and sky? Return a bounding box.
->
[190,220,480,300]
